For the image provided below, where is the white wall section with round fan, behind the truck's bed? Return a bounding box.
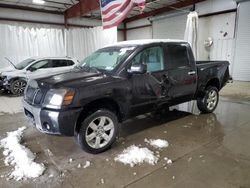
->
[198,13,236,73]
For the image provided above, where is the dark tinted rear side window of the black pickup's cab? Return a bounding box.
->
[167,44,189,69]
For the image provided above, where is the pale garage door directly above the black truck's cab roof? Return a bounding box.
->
[150,14,187,40]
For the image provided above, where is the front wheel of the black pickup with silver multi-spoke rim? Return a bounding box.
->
[77,109,119,154]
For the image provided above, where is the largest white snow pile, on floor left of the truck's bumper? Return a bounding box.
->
[0,127,45,181]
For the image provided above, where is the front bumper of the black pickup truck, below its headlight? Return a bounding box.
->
[23,100,82,136]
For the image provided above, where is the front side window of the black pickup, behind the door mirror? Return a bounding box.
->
[132,47,164,72]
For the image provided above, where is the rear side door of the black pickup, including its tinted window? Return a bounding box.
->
[166,43,197,101]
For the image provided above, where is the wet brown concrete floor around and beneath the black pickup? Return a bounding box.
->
[0,98,250,188]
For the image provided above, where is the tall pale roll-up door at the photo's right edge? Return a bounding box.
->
[233,1,250,81]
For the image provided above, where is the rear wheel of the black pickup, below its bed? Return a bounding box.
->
[197,86,219,113]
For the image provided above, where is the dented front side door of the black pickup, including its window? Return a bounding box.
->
[129,45,168,116]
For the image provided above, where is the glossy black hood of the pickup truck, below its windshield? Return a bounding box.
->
[35,70,106,88]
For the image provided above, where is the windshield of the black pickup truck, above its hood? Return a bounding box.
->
[79,47,135,72]
